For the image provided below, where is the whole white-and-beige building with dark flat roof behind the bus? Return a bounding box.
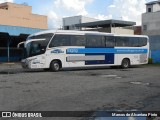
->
[63,16,136,35]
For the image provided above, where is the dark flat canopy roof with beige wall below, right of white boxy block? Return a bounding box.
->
[75,20,136,35]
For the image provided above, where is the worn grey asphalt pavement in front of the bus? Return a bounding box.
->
[0,64,160,120]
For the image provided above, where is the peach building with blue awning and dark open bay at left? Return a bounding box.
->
[0,2,48,62]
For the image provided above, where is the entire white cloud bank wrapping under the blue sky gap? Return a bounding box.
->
[43,0,151,28]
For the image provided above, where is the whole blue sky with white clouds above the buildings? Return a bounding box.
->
[0,0,154,29]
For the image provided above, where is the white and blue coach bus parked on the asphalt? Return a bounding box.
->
[22,30,149,72]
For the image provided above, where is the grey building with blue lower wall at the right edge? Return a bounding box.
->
[142,0,160,62]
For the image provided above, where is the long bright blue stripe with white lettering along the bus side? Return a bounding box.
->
[67,48,148,54]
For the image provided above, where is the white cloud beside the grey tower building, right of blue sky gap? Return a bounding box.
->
[107,0,146,25]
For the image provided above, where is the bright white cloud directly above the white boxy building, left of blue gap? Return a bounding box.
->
[47,0,93,28]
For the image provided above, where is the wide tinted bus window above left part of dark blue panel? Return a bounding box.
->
[86,35,105,47]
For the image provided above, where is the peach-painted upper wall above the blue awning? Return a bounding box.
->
[0,3,48,29]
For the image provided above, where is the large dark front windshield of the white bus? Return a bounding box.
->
[25,33,53,57]
